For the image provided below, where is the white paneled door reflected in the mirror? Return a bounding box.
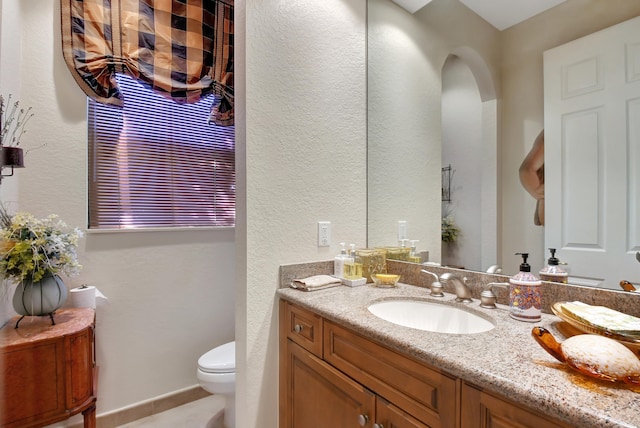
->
[544,17,640,289]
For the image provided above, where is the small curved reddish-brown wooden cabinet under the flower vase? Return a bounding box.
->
[0,308,97,428]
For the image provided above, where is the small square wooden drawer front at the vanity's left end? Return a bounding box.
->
[281,301,322,358]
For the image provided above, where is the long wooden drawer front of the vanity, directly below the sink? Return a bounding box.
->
[323,321,460,427]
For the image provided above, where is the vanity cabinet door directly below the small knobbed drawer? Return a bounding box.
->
[280,339,375,428]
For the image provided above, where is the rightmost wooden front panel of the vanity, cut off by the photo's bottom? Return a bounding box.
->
[462,384,570,428]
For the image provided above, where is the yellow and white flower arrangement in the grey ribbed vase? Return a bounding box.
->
[0,208,82,282]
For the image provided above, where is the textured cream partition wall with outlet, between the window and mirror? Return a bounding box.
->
[236,0,366,427]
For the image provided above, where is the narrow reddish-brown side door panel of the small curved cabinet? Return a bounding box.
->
[66,328,93,411]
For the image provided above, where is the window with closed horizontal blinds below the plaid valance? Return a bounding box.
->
[88,75,235,229]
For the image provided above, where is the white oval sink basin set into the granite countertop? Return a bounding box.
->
[367,300,495,334]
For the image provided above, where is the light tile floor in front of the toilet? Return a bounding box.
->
[118,395,224,428]
